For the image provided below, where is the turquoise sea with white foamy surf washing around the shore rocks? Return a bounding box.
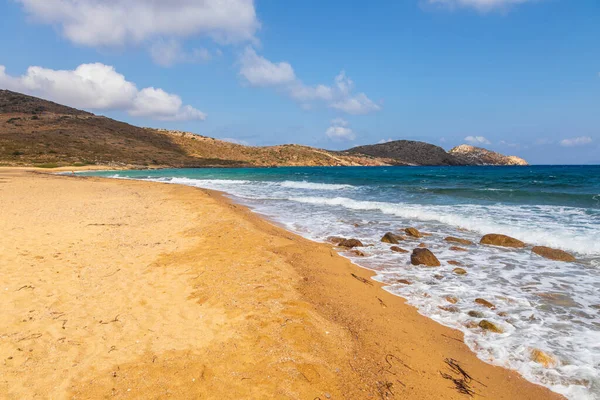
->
[85,166,600,399]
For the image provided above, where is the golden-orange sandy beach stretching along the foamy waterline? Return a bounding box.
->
[0,169,559,400]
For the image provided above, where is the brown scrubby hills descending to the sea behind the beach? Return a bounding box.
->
[0,90,524,168]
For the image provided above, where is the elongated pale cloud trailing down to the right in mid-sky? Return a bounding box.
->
[239,47,381,114]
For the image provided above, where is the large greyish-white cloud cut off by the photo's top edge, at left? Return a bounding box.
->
[17,0,260,47]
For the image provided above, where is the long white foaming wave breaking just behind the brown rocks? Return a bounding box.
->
[289,197,600,255]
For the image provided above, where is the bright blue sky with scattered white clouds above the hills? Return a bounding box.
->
[0,0,600,164]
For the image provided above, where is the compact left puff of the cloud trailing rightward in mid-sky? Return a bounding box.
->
[240,47,296,86]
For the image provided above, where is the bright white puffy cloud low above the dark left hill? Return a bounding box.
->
[0,63,206,120]
